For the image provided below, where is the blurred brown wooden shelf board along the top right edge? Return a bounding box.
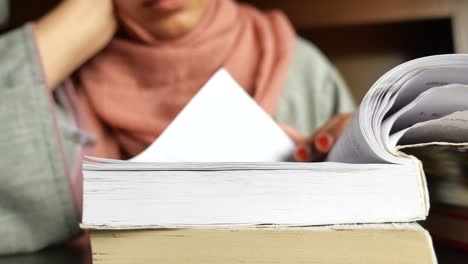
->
[248,0,453,28]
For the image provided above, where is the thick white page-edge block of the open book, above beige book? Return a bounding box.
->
[83,162,427,227]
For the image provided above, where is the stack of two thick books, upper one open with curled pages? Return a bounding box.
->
[82,55,468,264]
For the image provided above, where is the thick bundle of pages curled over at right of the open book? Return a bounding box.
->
[328,54,468,164]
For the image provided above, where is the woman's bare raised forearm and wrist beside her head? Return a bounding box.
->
[36,0,117,91]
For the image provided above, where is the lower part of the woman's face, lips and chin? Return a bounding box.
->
[114,0,208,39]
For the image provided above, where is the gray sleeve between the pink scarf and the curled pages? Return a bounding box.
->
[276,38,355,136]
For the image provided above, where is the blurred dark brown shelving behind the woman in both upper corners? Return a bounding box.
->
[6,0,468,103]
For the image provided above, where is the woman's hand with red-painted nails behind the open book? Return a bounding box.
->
[281,113,352,162]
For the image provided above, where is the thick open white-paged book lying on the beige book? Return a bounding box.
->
[83,55,468,228]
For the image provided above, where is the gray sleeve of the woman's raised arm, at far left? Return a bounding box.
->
[0,25,79,255]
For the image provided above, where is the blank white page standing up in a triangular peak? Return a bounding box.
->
[130,70,295,162]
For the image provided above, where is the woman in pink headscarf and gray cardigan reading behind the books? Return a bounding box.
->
[0,0,352,254]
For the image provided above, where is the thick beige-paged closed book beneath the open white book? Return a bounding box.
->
[90,224,437,264]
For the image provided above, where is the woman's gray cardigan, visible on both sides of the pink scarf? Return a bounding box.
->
[0,25,353,255]
